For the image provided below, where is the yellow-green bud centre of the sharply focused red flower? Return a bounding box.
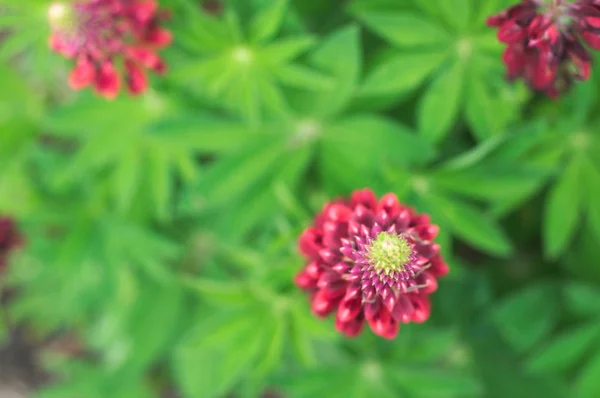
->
[367,232,413,274]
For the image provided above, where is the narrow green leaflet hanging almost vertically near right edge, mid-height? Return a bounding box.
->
[543,158,583,258]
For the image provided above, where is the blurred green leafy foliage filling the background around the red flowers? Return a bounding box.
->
[0,0,600,398]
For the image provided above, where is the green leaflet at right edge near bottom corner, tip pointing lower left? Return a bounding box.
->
[527,322,600,372]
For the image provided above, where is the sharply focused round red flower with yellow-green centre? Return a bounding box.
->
[295,189,448,339]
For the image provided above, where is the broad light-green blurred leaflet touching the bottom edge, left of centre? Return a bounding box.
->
[173,307,267,398]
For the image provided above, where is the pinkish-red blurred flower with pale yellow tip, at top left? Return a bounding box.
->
[48,0,171,99]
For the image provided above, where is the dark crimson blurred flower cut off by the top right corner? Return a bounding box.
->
[487,0,600,98]
